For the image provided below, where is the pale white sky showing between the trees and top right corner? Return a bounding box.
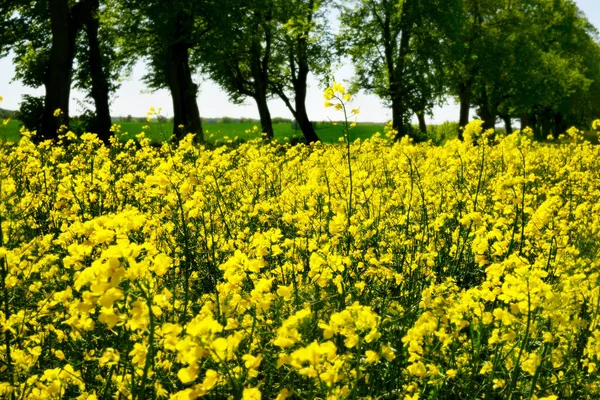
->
[0,0,600,124]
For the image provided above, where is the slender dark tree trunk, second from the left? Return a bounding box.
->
[85,0,112,145]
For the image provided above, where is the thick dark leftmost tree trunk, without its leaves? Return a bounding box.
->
[40,0,76,140]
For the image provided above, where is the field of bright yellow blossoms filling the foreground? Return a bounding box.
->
[0,122,600,400]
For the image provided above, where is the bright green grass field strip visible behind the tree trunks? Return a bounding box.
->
[0,120,383,143]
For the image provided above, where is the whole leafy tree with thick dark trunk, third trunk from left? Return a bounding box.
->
[118,0,211,141]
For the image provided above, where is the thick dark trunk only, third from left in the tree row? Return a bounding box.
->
[165,16,204,142]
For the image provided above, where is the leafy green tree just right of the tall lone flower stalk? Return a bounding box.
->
[339,0,455,137]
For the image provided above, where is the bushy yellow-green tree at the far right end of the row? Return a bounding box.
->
[509,0,600,138]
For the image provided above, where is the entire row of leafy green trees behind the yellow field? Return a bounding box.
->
[0,0,600,143]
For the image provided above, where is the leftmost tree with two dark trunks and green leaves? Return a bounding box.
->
[0,0,117,143]
